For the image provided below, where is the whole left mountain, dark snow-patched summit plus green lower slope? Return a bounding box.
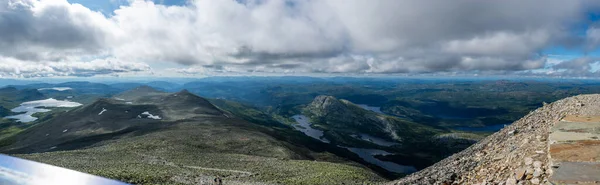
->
[0,88,385,184]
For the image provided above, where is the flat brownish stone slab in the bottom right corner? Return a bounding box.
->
[550,162,600,184]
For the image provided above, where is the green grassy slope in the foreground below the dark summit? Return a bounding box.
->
[17,119,384,184]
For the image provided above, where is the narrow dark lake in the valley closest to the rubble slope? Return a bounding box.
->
[342,147,417,173]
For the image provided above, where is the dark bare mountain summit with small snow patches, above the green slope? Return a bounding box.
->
[2,86,226,153]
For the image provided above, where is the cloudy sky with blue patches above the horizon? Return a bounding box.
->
[0,0,600,78]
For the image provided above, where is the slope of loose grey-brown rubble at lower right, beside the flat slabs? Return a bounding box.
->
[390,94,600,185]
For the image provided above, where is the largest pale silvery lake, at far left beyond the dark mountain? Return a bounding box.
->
[5,98,81,123]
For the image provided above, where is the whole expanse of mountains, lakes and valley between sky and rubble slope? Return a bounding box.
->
[0,77,600,184]
